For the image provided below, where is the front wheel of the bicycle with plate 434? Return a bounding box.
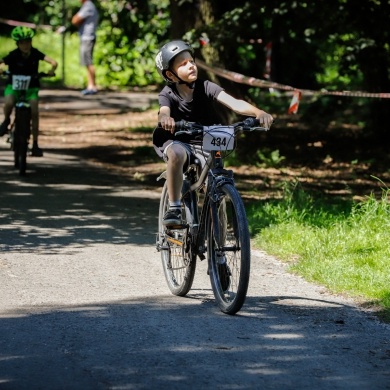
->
[207,184,250,315]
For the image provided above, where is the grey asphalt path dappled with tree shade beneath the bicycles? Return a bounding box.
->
[0,93,390,390]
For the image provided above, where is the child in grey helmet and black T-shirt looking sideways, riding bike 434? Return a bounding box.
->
[153,41,273,226]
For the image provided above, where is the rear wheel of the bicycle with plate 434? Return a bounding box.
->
[158,182,196,296]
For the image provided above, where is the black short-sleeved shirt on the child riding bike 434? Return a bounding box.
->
[153,79,223,154]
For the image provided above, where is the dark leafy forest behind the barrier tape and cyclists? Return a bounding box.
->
[0,0,390,144]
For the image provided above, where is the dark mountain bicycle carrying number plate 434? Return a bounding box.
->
[156,118,268,315]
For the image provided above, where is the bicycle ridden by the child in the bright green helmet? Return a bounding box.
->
[3,71,51,176]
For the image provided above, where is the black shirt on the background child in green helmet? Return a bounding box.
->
[3,47,45,88]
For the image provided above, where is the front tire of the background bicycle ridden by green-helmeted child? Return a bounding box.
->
[14,107,31,176]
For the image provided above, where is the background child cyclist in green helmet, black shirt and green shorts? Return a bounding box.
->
[0,26,57,157]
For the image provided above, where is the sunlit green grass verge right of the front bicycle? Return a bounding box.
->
[248,180,390,322]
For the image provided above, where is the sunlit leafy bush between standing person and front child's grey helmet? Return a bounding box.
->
[96,0,170,87]
